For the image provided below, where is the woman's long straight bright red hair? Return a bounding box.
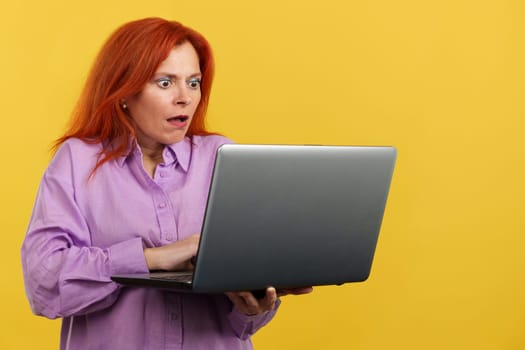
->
[53,18,214,173]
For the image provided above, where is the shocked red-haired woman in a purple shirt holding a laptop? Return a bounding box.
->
[22,18,309,350]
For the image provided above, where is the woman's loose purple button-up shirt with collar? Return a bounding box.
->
[22,136,275,350]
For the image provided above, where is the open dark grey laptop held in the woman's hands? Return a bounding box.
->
[111,144,397,293]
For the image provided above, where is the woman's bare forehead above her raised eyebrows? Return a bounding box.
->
[157,42,200,75]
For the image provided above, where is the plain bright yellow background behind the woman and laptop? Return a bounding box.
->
[0,0,525,350]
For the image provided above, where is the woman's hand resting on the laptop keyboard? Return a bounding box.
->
[144,234,200,271]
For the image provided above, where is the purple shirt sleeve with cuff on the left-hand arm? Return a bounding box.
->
[21,144,148,318]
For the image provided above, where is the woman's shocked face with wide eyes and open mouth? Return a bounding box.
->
[125,42,202,152]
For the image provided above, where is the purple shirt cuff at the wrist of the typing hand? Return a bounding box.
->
[108,237,149,275]
